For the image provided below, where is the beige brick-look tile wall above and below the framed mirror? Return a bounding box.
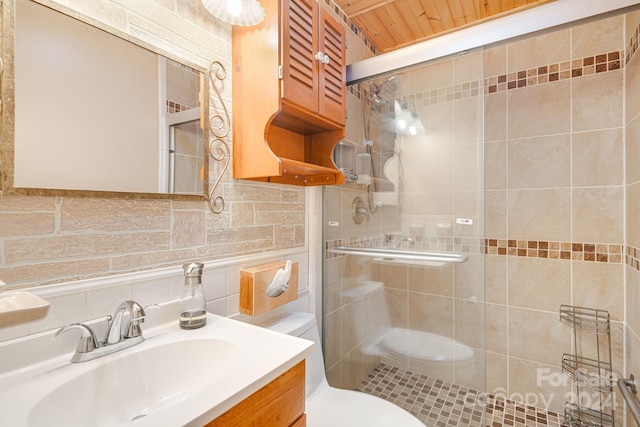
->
[0,0,305,287]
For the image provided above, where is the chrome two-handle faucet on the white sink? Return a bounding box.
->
[55,300,146,363]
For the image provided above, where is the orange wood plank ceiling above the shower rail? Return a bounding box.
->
[335,0,555,53]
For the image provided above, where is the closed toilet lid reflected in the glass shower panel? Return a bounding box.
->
[380,328,473,362]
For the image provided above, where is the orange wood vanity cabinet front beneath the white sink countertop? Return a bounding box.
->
[206,360,306,427]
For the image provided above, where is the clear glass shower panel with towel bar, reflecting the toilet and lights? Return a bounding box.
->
[323,49,485,422]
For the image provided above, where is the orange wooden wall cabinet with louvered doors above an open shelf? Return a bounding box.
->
[232,0,346,185]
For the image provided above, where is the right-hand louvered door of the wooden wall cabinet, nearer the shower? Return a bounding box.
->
[318,8,346,125]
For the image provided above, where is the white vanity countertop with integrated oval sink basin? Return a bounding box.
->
[0,314,313,427]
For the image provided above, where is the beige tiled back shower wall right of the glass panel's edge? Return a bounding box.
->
[485,15,629,417]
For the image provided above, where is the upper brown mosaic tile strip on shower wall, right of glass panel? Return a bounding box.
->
[484,50,624,93]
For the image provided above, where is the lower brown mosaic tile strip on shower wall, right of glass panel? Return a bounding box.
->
[485,239,620,264]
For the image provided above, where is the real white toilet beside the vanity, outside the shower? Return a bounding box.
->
[260,313,424,427]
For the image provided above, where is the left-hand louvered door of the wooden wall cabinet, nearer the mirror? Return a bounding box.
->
[281,0,320,112]
